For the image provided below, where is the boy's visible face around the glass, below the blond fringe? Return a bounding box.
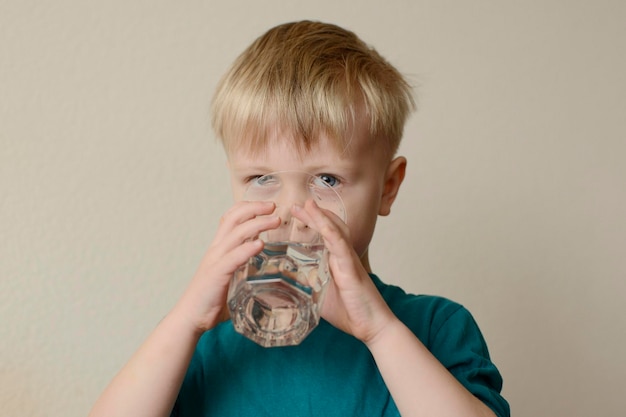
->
[228,115,404,257]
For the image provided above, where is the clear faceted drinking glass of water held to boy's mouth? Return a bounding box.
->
[228,171,346,347]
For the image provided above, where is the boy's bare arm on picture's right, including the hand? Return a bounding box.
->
[294,202,502,417]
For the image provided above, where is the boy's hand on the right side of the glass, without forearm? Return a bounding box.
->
[293,200,395,344]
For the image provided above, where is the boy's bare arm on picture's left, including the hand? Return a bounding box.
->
[89,202,280,417]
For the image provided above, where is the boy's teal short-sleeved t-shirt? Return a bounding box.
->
[172,275,510,417]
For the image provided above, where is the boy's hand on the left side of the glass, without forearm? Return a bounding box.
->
[172,201,280,334]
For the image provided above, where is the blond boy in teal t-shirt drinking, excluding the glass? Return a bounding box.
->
[86,21,509,417]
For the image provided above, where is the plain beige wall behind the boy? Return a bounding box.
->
[0,0,626,417]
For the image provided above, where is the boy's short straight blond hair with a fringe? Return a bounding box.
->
[212,21,415,156]
